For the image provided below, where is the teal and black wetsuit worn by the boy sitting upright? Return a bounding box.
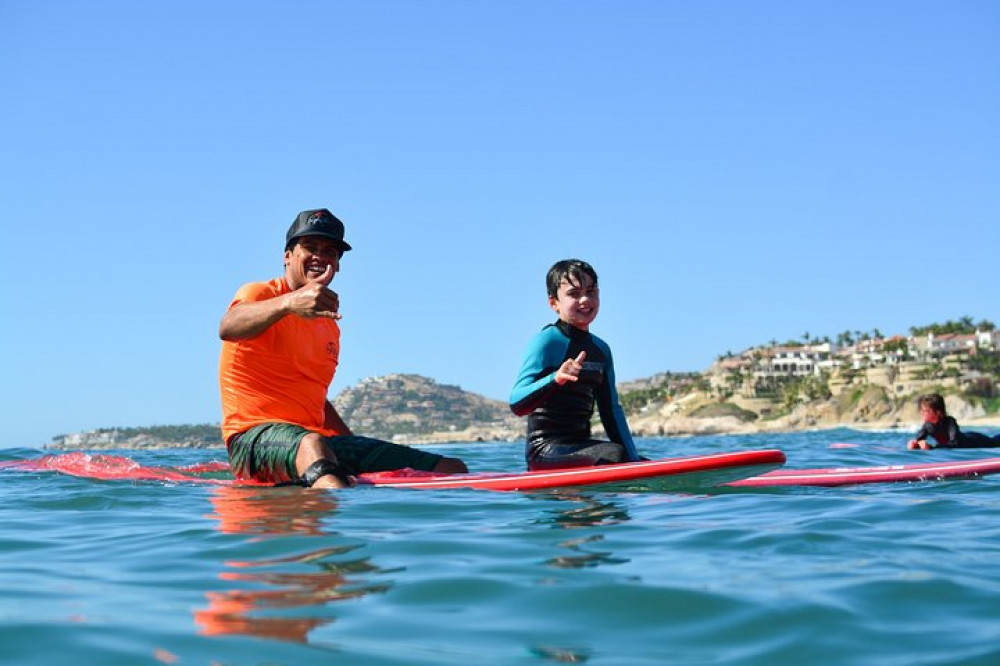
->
[510,320,639,469]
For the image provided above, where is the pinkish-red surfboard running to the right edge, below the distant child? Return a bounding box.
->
[727,458,1000,487]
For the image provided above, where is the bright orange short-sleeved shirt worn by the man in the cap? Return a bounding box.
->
[219,278,340,442]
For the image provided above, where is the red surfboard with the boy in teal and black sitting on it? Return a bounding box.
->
[358,449,785,491]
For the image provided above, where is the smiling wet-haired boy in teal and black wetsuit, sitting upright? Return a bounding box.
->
[510,259,641,470]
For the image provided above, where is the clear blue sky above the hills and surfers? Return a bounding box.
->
[0,0,1000,446]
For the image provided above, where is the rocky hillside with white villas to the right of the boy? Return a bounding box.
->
[620,317,1000,436]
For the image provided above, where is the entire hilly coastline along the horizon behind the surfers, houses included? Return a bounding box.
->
[49,317,1000,449]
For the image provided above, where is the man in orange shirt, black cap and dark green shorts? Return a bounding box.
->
[219,208,468,488]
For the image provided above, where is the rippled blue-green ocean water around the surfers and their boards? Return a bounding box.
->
[0,429,1000,666]
